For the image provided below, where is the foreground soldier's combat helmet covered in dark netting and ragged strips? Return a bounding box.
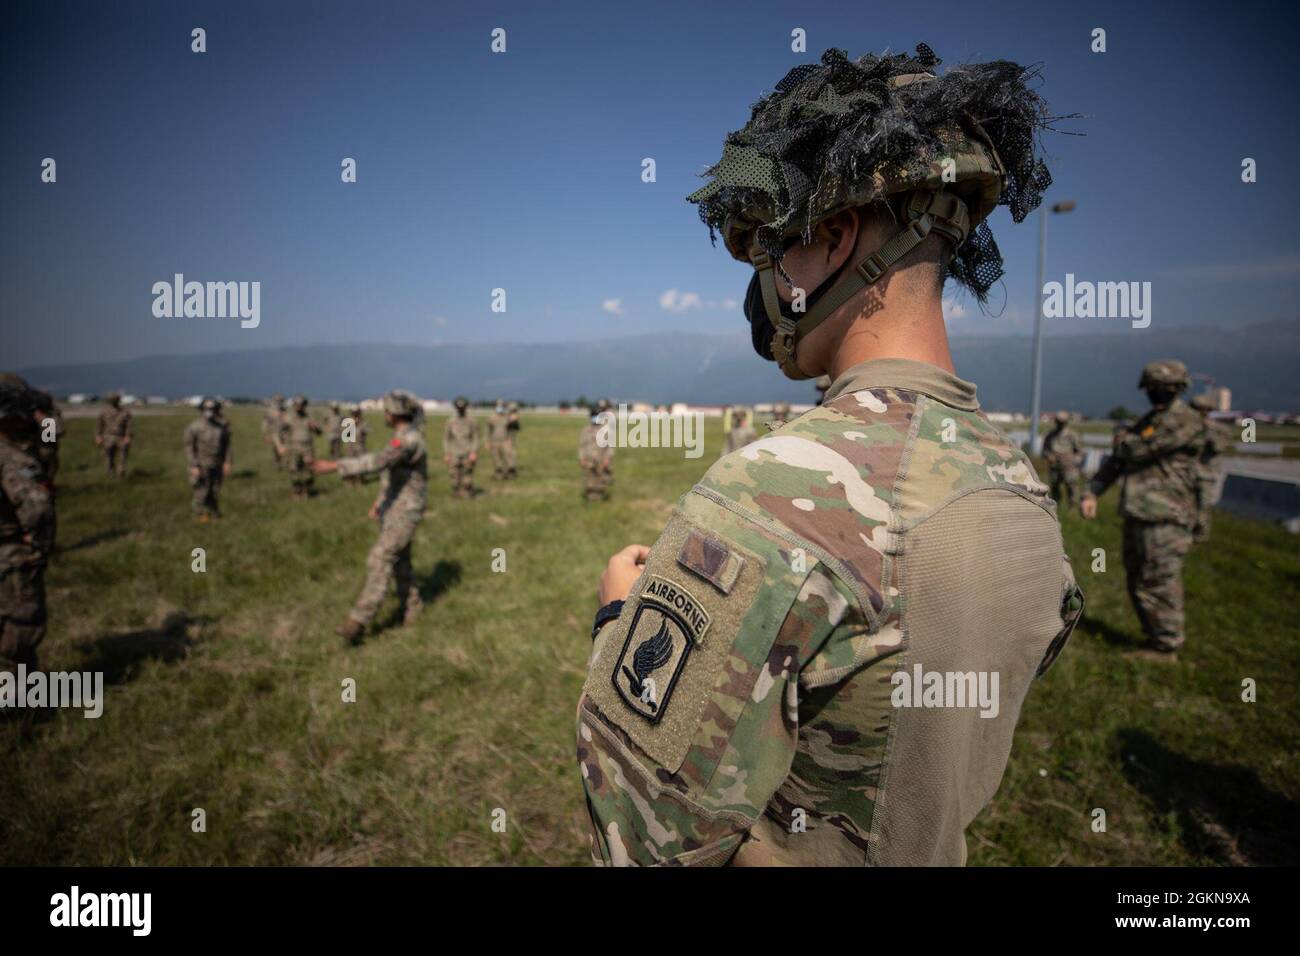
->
[688,43,1052,378]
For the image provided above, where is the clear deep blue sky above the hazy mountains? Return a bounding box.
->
[0,0,1300,367]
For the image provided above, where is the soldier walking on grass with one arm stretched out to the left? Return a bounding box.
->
[312,392,429,644]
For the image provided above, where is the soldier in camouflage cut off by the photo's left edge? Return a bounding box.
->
[0,376,55,670]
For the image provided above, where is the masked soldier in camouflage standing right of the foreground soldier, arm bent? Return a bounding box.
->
[1082,359,1205,659]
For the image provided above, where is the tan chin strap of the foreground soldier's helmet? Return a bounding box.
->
[749,189,970,381]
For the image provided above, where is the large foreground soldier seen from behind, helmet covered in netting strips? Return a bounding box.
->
[577,44,1082,865]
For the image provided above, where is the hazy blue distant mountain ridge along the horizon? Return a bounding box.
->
[20,321,1300,415]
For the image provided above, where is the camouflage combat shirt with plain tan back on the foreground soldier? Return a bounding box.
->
[577,359,1083,865]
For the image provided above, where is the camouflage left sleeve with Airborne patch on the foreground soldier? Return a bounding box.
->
[577,494,845,865]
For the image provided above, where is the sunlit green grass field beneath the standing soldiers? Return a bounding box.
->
[0,408,1300,865]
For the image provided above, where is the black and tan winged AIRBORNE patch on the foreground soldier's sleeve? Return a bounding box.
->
[612,575,710,723]
